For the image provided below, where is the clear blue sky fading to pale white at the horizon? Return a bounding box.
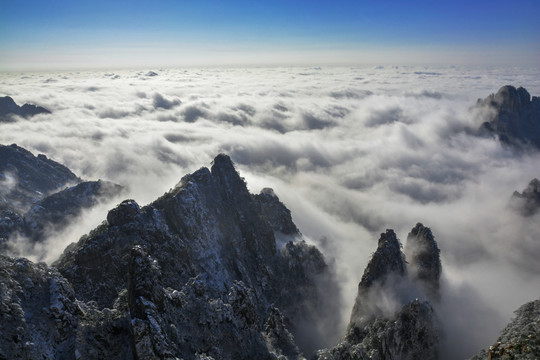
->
[0,0,540,70]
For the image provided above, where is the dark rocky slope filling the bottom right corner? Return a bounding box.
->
[471,299,540,360]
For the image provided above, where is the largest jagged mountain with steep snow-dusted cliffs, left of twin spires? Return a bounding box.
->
[0,155,340,359]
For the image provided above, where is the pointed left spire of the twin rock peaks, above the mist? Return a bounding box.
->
[359,229,406,289]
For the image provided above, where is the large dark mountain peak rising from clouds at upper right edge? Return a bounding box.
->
[476,85,540,149]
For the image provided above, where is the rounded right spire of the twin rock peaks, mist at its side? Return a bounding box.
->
[405,223,442,297]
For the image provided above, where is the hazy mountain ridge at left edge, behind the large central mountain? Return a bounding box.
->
[0,144,124,252]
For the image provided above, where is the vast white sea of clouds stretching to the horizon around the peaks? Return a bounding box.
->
[0,66,540,358]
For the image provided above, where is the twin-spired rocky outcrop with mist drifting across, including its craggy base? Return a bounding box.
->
[315,224,441,360]
